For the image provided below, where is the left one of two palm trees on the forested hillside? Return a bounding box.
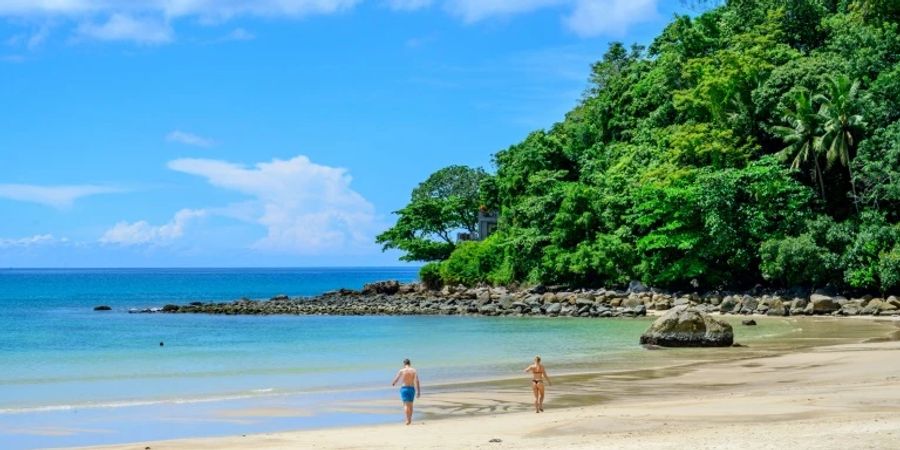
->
[772,89,825,201]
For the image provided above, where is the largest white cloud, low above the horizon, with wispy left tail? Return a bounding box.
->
[169,156,375,255]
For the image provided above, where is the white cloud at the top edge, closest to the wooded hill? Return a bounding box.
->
[564,0,659,37]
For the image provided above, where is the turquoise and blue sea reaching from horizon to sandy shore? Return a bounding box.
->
[0,267,800,449]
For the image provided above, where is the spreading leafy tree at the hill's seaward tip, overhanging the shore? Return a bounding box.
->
[376,166,487,261]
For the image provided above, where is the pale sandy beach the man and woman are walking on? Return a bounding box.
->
[89,316,900,450]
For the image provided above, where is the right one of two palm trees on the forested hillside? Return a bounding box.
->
[813,75,865,204]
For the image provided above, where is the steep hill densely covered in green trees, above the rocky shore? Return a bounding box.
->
[377,0,900,296]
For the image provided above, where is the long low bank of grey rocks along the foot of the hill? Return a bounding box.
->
[121,281,900,318]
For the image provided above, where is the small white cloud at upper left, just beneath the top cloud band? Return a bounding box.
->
[77,13,173,44]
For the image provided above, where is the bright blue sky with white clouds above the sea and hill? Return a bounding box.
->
[0,0,688,267]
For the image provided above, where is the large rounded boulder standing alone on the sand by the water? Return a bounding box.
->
[641,305,734,347]
